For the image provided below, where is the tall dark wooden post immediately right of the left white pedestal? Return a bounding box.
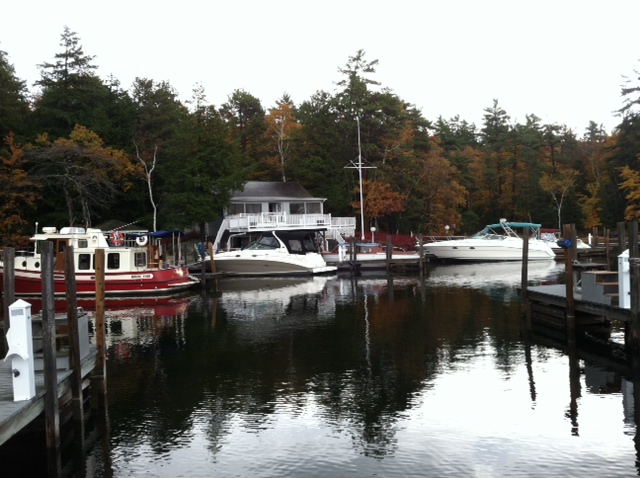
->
[38,241,62,476]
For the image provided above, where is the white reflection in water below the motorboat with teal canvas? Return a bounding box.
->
[427,261,564,289]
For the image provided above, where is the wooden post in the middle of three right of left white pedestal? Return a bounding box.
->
[64,246,84,444]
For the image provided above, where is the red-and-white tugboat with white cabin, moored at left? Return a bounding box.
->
[0,227,198,297]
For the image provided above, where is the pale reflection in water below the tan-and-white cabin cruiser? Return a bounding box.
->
[217,276,329,320]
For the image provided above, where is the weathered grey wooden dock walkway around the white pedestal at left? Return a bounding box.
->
[0,346,97,445]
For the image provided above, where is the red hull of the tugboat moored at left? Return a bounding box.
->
[0,267,197,296]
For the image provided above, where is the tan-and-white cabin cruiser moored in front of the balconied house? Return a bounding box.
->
[213,229,337,276]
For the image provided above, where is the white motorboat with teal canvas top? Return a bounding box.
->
[424,219,556,261]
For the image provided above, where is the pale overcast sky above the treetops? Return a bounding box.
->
[0,0,640,137]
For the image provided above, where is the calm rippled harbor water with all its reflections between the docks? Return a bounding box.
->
[0,264,639,478]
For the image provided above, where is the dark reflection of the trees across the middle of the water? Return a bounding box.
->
[102,281,520,458]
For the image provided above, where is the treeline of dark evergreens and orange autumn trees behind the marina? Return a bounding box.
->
[0,28,640,245]
